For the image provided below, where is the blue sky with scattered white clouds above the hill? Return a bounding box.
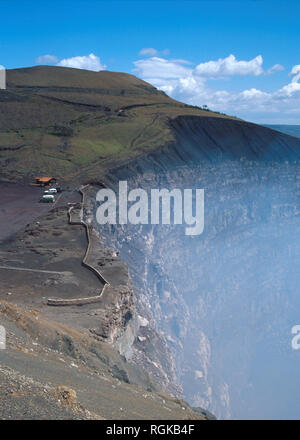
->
[0,0,300,124]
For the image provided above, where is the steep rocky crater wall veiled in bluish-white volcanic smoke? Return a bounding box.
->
[90,117,300,418]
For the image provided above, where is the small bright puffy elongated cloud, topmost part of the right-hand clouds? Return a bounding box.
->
[195,54,263,78]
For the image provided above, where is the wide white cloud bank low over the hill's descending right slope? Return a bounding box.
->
[134,55,300,123]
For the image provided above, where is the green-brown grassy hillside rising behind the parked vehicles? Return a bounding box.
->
[0,66,234,184]
